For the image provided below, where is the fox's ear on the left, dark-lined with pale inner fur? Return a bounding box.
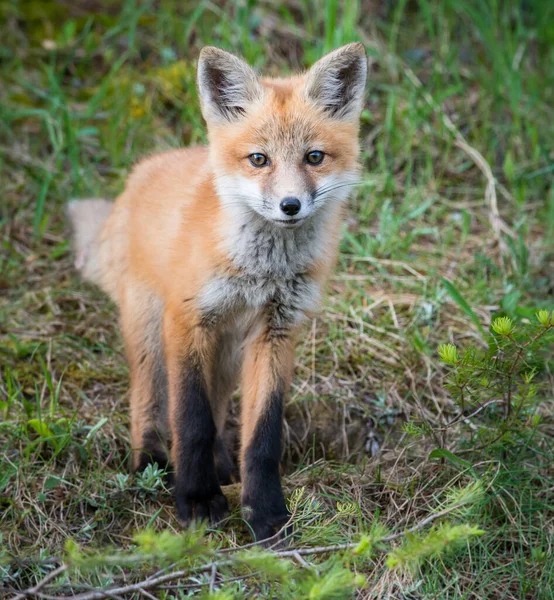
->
[198,46,263,122]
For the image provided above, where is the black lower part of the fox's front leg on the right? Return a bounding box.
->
[242,391,289,540]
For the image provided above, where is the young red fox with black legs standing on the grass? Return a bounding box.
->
[68,43,367,540]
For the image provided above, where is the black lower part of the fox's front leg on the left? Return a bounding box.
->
[173,361,228,525]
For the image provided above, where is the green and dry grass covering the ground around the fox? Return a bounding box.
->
[0,0,554,599]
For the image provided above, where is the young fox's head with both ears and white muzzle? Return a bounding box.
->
[198,43,367,228]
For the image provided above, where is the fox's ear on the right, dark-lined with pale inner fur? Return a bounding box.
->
[305,43,367,120]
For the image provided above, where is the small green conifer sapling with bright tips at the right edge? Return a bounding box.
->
[438,310,554,450]
